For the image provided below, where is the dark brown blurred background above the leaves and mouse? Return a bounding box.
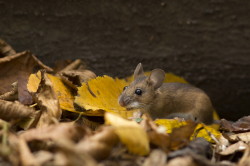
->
[0,0,250,120]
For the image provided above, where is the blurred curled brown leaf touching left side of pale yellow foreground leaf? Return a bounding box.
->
[76,126,118,160]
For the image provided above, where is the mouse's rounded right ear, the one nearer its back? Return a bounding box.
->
[148,69,165,89]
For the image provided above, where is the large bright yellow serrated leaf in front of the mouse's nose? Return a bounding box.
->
[75,75,133,118]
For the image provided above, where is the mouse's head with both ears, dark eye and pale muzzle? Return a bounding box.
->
[118,63,165,109]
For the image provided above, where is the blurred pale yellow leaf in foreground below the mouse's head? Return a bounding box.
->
[105,113,150,155]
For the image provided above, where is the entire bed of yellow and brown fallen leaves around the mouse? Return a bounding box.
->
[0,40,250,166]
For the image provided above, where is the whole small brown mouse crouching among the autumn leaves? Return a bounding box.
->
[118,63,214,124]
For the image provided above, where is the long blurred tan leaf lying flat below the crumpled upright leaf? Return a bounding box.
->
[20,123,87,142]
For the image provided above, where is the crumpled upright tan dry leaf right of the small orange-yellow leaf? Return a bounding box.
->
[33,72,62,127]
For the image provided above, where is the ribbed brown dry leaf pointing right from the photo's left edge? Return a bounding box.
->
[0,100,35,120]
